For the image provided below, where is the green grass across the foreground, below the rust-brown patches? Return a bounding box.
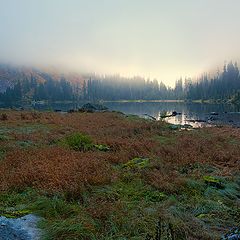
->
[0,174,240,240]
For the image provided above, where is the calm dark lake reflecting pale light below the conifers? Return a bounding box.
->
[7,101,240,127]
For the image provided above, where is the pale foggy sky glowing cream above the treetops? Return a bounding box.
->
[0,0,240,85]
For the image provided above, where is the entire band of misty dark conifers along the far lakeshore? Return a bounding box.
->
[0,62,240,103]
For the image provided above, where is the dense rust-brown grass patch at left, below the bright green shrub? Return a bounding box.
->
[0,147,111,194]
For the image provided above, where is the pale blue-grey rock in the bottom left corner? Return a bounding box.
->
[0,214,41,240]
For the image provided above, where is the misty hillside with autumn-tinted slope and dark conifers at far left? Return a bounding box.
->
[0,64,86,103]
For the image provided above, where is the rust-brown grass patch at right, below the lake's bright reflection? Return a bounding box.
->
[146,128,240,192]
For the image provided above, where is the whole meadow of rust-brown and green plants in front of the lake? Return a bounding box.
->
[0,110,240,240]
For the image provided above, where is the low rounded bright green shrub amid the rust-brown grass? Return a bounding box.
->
[60,133,93,151]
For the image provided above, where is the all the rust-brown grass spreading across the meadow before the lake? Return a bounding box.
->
[0,111,240,195]
